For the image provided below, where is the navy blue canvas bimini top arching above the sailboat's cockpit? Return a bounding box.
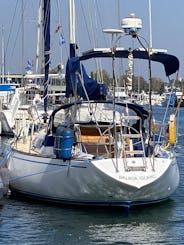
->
[79,48,179,76]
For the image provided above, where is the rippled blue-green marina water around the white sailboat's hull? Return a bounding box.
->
[0,107,184,245]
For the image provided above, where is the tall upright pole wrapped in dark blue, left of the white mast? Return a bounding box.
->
[43,0,50,119]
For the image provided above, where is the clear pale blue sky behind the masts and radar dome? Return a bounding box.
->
[0,0,184,82]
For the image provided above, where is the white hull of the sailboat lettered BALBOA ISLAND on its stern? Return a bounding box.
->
[8,151,179,207]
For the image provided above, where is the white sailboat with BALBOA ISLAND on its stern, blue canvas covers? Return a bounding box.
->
[8,1,179,208]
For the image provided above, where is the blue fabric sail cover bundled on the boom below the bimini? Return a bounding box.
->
[65,57,107,100]
